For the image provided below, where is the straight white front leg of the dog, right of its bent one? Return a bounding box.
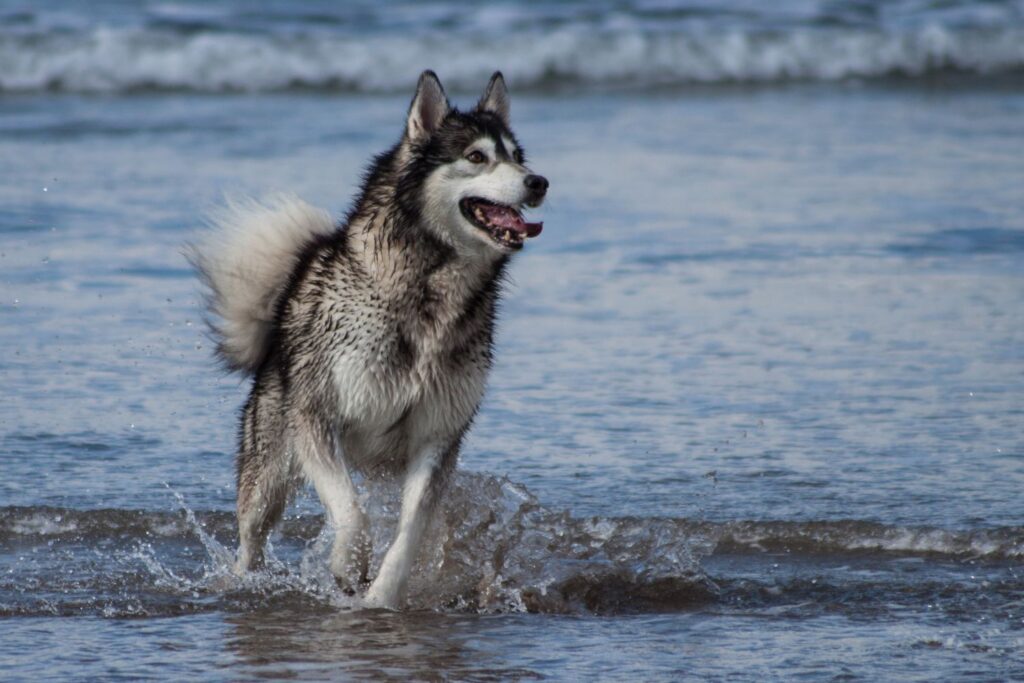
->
[365,445,456,609]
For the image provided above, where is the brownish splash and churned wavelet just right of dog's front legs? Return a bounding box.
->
[397,474,712,612]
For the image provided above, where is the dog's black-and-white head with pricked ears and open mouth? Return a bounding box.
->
[399,71,548,256]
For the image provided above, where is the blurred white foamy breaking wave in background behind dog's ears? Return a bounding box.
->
[0,24,1024,93]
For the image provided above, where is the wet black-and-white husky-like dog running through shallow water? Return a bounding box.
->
[188,71,548,609]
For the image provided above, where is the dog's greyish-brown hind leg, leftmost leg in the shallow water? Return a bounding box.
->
[234,378,294,575]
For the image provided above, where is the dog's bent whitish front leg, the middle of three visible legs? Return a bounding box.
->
[292,418,371,589]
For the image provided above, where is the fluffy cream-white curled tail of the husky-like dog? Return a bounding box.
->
[185,195,337,373]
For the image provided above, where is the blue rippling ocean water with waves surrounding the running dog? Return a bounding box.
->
[0,0,1024,681]
